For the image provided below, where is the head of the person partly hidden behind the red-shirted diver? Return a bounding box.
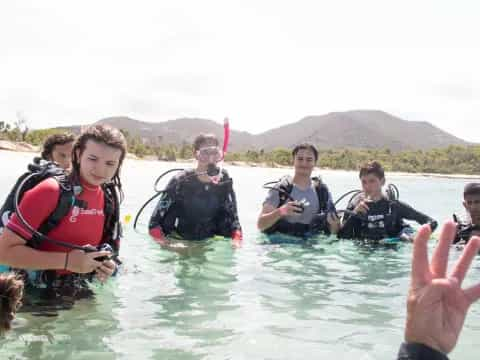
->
[41,133,75,170]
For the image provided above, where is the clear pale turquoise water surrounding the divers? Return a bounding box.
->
[0,151,480,360]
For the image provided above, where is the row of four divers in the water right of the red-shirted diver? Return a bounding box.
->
[149,134,480,248]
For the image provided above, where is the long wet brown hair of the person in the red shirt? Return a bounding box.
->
[71,124,127,198]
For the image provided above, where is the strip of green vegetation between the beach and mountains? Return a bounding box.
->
[0,121,480,175]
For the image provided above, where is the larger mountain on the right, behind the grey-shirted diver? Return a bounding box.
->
[257,110,469,151]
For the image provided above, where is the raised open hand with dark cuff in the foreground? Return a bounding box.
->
[397,221,480,360]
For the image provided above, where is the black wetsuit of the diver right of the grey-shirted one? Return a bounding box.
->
[337,198,437,240]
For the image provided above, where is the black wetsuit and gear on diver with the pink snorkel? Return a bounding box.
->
[149,170,241,240]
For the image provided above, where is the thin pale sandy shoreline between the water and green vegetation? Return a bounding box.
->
[0,145,480,180]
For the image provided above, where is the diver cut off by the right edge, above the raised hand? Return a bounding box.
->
[454,183,480,244]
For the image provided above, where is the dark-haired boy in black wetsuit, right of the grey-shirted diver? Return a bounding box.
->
[337,161,437,240]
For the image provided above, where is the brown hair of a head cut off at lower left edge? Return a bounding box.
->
[0,273,23,335]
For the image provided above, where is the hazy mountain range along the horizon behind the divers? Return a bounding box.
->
[58,110,471,151]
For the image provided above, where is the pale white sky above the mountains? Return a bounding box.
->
[0,0,480,142]
